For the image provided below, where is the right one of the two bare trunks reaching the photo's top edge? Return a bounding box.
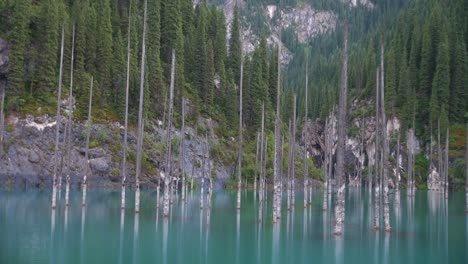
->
[135,0,147,213]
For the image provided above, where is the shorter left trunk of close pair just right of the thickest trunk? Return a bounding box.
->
[374,69,380,229]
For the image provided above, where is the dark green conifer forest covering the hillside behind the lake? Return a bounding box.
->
[0,0,468,183]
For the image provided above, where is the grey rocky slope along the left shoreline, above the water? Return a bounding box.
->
[0,110,234,188]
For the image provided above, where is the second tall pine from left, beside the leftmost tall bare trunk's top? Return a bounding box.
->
[34,0,59,96]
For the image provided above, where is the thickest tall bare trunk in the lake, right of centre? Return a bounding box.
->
[333,21,348,235]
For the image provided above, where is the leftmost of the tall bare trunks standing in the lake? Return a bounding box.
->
[52,26,65,209]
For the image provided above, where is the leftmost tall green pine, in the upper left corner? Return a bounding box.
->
[7,0,31,98]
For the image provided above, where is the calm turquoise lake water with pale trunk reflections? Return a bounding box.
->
[0,189,468,264]
